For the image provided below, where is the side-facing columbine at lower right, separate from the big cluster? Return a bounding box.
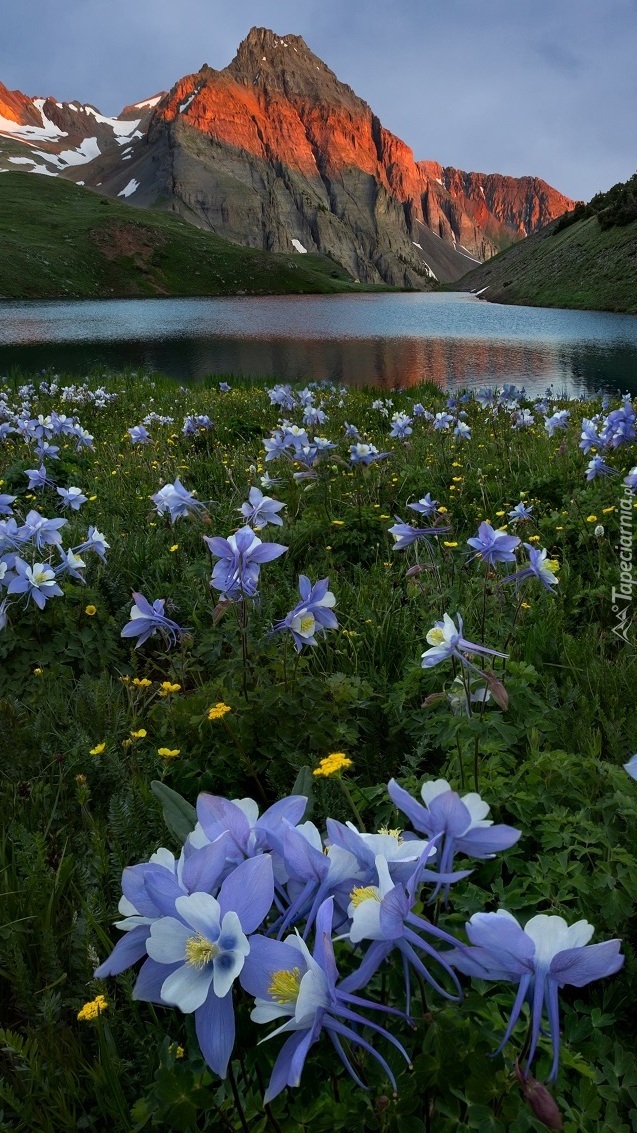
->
[447,909,623,1082]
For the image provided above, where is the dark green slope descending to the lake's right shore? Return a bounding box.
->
[456,174,637,314]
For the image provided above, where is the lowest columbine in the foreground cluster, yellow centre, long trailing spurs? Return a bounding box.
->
[240,898,409,1104]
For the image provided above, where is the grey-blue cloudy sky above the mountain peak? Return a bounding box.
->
[0,0,637,199]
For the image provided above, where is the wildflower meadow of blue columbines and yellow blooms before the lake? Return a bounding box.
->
[0,373,637,1133]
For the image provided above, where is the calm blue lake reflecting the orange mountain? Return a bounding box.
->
[0,293,637,393]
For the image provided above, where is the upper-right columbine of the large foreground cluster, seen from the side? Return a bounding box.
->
[388,780,521,896]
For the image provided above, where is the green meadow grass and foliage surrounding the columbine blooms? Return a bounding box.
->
[0,372,637,1133]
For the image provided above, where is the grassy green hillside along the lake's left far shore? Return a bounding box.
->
[0,172,376,299]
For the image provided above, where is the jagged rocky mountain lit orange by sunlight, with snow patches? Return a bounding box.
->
[0,28,574,288]
